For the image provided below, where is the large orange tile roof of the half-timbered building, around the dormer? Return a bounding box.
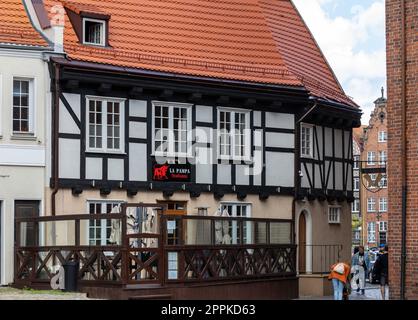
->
[44,0,355,106]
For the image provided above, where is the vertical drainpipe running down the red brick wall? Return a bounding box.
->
[400,0,408,300]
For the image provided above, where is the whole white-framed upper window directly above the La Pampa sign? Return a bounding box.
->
[152,101,192,157]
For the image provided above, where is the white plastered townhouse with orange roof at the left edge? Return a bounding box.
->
[0,0,51,285]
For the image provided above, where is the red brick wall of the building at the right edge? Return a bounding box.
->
[386,0,418,299]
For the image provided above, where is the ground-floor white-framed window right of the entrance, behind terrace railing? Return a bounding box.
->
[220,203,252,244]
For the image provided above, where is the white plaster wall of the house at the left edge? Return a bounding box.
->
[0,49,51,285]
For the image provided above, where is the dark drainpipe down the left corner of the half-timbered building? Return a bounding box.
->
[51,63,60,216]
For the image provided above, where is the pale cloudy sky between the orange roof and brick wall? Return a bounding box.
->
[293,0,386,124]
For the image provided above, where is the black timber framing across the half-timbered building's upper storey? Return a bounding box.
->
[51,58,360,197]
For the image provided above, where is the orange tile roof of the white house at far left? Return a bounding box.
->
[0,0,48,47]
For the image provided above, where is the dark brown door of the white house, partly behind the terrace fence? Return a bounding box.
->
[15,201,39,246]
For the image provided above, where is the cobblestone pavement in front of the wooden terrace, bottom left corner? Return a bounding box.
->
[0,287,89,300]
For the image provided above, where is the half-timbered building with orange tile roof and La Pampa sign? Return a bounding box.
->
[12,0,361,300]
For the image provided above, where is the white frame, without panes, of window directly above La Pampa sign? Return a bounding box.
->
[151,101,193,158]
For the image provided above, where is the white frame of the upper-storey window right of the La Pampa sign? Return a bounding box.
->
[217,107,251,161]
